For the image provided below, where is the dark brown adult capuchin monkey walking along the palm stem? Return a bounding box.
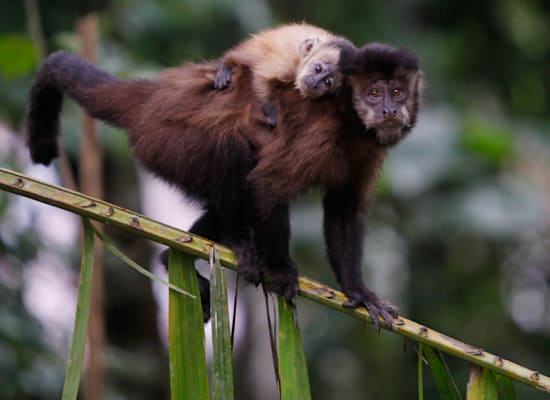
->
[27,31,422,327]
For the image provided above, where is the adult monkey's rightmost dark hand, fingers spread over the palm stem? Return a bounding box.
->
[344,288,399,331]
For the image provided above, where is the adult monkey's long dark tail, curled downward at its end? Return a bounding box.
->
[26,51,120,165]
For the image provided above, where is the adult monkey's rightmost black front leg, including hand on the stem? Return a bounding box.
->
[323,189,397,330]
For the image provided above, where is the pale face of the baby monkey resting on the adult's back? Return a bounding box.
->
[295,43,343,99]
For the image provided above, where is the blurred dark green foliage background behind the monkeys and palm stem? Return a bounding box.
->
[0,0,550,400]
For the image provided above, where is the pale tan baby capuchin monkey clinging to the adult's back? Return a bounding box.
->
[214,24,349,127]
